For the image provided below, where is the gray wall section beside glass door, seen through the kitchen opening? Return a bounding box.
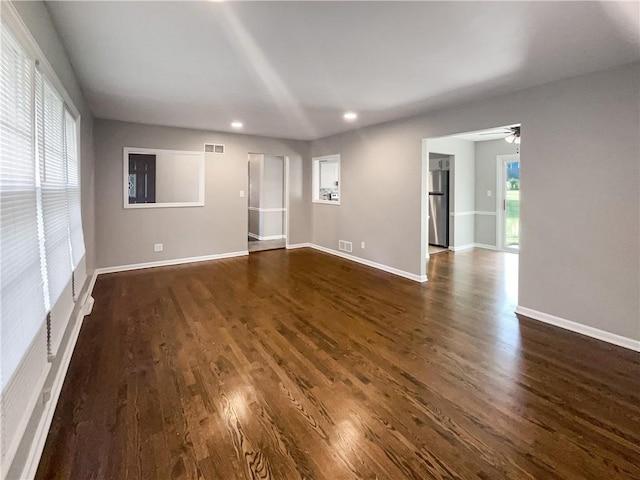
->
[475,139,528,247]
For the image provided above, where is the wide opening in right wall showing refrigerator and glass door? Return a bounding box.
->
[422,125,526,288]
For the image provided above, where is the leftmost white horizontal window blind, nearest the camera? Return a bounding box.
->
[0,25,46,391]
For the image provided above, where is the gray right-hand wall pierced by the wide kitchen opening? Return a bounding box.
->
[311,63,640,339]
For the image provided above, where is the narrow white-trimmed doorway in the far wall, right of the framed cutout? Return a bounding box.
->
[247,153,288,253]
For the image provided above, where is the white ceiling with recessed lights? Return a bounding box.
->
[47,1,640,139]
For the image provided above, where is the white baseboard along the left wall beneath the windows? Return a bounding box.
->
[20,271,98,478]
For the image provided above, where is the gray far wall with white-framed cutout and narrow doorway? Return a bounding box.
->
[95,120,310,267]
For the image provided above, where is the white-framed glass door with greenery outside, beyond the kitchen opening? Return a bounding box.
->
[496,155,520,253]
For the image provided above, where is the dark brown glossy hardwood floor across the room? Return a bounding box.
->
[37,249,640,480]
